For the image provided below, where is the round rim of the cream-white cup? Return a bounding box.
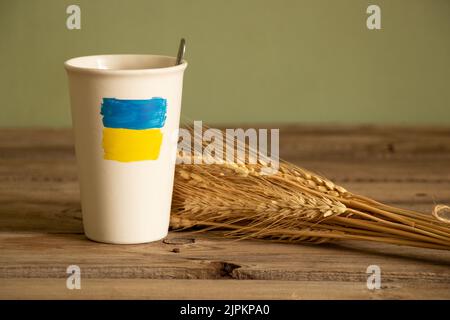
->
[64,53,188,75]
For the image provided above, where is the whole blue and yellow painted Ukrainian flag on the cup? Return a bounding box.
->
[100,98,167,162]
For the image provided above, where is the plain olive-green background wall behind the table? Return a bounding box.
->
[0,0,450,126]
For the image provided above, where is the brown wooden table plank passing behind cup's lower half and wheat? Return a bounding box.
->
[0,160,450,232]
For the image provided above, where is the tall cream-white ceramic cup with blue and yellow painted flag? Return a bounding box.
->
[64,55,187,244]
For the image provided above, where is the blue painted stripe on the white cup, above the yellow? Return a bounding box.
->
[100,98,167,130]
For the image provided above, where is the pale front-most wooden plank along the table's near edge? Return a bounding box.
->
[0,277,450,300]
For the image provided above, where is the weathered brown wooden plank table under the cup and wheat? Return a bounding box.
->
[0,125,450,299]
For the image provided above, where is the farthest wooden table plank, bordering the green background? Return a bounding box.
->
[0,124,450,160]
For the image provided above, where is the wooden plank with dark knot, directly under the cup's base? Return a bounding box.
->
[0,232,450,282]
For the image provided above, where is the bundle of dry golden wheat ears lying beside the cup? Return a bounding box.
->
[171,127,450,250]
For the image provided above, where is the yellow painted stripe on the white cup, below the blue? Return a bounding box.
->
[103,128,163,162]
